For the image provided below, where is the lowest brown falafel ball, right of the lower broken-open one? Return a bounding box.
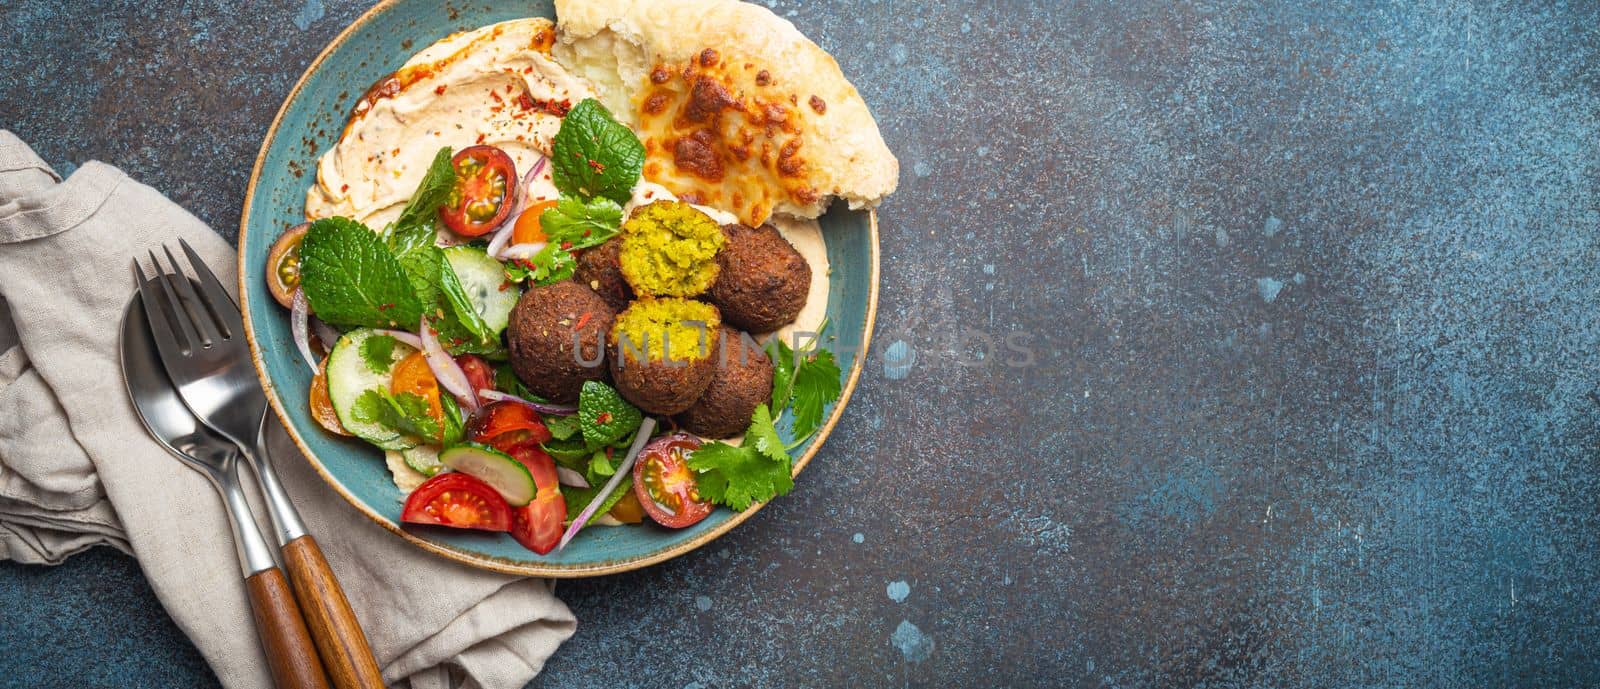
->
[674,326,773,438]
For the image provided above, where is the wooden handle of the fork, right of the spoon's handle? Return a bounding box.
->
[282,536,384,689]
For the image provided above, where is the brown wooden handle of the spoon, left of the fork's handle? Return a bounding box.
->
[245,568,328,689]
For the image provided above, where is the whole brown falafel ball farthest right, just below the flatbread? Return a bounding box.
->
[706,224,811,333]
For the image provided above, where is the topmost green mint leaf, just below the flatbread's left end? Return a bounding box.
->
[550,98,645,203]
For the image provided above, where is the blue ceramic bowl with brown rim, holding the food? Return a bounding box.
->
[238,0,878,577]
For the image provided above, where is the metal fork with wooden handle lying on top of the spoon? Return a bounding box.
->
[134,240,384,689]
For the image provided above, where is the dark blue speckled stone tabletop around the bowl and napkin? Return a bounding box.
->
[0,0,1600,689]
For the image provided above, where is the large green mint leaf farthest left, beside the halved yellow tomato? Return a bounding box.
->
[301,217,422,328]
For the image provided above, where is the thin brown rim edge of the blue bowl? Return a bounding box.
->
[238,0,878,579]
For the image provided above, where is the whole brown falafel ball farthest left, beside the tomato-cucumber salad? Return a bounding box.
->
[506,280,616,403]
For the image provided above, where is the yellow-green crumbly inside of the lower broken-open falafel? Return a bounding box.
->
[611,297,722,361]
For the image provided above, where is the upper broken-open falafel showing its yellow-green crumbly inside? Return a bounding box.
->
[618,201,726,297]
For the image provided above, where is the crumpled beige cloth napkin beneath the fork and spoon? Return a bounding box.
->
[0,129,576,689]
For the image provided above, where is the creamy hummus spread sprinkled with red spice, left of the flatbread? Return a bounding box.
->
[306,18,594,229]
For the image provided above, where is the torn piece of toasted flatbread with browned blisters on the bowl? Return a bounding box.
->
[554,0,899,225]
